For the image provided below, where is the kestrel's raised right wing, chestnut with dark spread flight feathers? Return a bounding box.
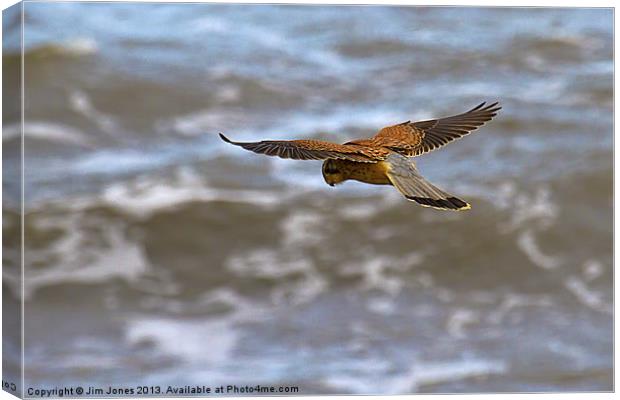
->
[371,102,502,156]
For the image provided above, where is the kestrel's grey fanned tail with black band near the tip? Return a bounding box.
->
[386,154,471,211]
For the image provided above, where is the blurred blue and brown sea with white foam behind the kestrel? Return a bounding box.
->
[3,2,614,394]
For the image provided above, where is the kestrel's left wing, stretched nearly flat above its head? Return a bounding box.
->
[220,133,389,163]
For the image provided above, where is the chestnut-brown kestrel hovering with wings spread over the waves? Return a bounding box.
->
[220,102,501,211]
